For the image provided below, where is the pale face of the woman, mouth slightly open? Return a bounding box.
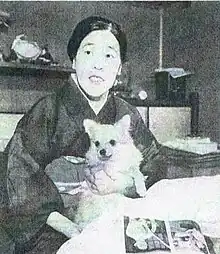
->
[73,30,121,98]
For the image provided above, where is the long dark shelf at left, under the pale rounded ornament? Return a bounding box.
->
[0,62,74,78]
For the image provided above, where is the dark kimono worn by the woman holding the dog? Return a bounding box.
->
[2,81,165,254]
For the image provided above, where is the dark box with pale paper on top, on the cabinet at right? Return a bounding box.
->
[155,68,192,102]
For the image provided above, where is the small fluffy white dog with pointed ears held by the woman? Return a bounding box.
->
[83,115,146,197]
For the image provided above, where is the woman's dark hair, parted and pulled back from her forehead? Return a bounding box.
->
[67,16,127,62]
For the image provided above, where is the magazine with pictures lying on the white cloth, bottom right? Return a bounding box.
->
[124,216,210,254]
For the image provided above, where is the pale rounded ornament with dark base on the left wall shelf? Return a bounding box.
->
[3,34,58,65]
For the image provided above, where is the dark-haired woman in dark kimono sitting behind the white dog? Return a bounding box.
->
[1,17,164,254]
